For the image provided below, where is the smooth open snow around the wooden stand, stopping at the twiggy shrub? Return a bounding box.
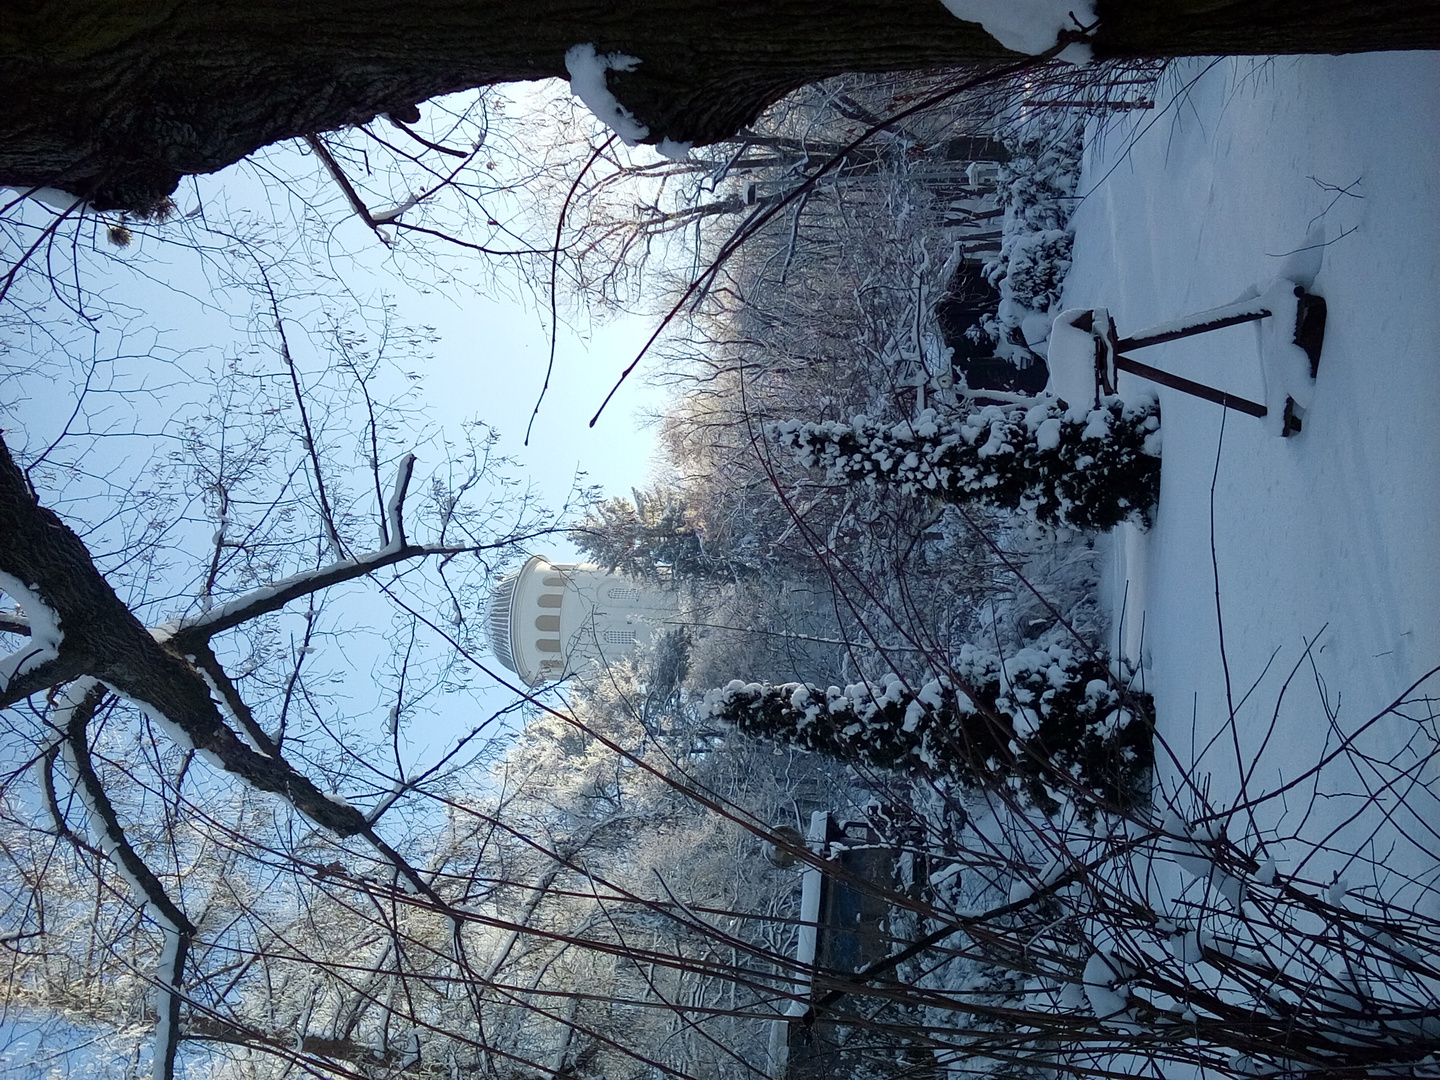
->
[1064,53,1440,877]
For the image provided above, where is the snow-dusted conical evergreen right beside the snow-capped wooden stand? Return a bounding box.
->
[773,397,1161,530]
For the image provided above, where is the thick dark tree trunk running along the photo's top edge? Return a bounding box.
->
[0,0,1440,212]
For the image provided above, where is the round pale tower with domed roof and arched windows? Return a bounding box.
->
[490,554,678,687]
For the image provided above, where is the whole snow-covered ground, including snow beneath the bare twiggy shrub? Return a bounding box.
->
[910,53,1440,1077]
